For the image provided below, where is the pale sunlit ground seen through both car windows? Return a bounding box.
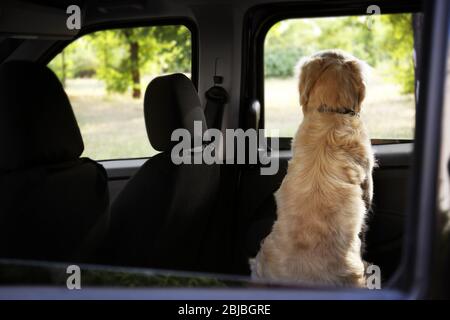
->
[66,75,415,160]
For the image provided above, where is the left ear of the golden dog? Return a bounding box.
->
[299,57,324,109]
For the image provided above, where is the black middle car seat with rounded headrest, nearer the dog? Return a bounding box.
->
[108,74,220,271]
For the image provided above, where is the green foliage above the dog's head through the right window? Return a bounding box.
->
[264,14,414,93]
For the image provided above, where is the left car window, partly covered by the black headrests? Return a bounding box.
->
[49,25,192,160]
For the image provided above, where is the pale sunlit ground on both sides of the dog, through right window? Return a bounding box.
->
[264,71,415,139]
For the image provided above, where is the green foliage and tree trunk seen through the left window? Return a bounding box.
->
[49,26,191,98]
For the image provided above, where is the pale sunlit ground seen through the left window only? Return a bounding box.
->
[67,79,157,160]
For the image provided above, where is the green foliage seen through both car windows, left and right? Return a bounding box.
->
[50,14,414,97]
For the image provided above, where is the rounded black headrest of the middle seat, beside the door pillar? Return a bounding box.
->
[144,73,207,151]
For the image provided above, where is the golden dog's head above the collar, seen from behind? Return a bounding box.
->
[299,50,366,114]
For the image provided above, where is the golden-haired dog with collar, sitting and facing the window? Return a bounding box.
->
[250,50,374,287]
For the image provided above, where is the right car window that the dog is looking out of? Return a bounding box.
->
[264,13,415,140]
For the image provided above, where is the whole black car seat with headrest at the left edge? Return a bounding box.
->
[0,61,109,261]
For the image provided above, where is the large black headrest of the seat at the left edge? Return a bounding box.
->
[0,61,84,171]
